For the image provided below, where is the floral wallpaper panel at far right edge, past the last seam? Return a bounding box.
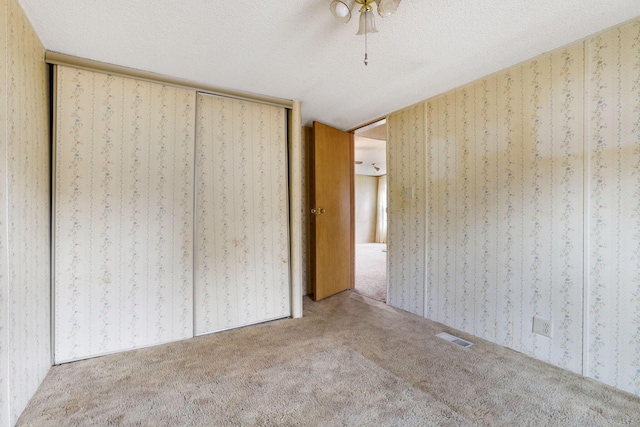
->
[585,20,640,395]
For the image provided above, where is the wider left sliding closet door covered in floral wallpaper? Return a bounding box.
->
[54,67,195,363]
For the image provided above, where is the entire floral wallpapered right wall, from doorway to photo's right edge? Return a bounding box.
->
[389,21,640,394]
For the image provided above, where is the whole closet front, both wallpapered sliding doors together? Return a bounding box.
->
[53,66,291,363]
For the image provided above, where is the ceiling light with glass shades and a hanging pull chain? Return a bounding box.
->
[329,0,402,65]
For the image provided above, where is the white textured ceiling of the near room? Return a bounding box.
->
[19,0,640,130]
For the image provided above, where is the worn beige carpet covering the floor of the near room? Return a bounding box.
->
[18,292,640,426]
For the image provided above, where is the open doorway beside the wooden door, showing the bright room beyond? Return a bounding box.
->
[354,120,387,302]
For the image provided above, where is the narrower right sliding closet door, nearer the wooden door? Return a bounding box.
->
[195,94,291,335]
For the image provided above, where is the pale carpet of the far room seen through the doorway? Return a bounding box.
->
[354,243,387,302]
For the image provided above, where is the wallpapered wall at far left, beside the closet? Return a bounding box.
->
[0,0,51,425]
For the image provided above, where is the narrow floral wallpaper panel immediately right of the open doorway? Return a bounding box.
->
[387,103,427,316]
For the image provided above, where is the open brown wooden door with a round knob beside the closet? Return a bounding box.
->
[309,122,354,301]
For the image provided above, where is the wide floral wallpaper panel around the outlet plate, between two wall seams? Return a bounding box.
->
[427,44,584,378]
